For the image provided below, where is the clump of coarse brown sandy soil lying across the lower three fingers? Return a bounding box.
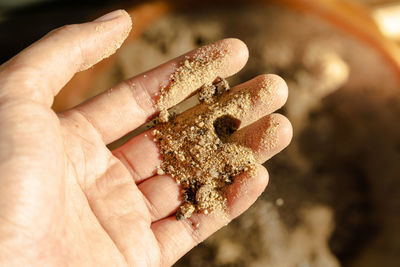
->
[153,76,255,220]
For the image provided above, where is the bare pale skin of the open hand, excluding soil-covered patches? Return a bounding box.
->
[0,10,292,266]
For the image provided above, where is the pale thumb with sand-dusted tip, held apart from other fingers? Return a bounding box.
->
[0,10,132,106]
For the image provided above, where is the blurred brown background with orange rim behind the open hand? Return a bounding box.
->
[0,0,400,267]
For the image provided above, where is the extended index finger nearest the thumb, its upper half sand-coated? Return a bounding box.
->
[66,39,248,143]
